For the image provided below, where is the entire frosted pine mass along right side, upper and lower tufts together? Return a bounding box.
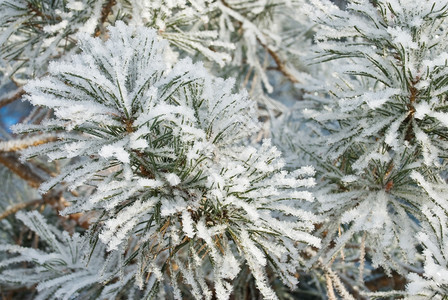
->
[276,0,448,274]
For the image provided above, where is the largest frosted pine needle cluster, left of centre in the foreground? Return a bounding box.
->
[16,22,320,299]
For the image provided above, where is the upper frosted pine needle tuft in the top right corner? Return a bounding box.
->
[312,0,447,167]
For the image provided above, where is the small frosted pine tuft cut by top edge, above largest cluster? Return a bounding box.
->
[114,0,235,67]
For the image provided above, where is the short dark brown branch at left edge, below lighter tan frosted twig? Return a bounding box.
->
[0,153,44,188]
